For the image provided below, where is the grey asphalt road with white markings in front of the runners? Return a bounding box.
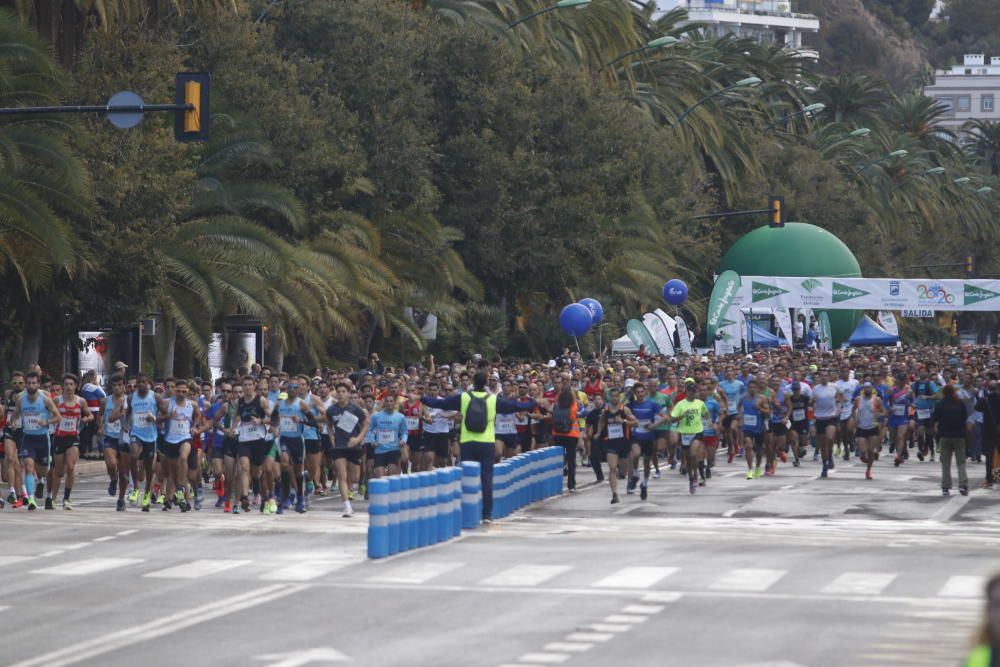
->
[0,452,1000,667]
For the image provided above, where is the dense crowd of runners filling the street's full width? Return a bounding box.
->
[0,347,1000,517]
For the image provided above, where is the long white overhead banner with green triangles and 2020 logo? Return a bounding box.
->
[733,276,1000,311]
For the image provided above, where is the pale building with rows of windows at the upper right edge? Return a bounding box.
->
[924,54,1000,130]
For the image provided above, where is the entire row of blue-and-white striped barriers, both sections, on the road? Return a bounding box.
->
[368,447,563,558]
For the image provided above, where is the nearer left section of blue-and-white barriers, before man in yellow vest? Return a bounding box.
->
[368,467,464,558]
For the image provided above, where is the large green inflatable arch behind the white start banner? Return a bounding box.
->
[718,222,861,348]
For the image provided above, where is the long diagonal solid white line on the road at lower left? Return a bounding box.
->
[9,584,308,667]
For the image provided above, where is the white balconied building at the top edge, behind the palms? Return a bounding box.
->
[656,0,819,59]
